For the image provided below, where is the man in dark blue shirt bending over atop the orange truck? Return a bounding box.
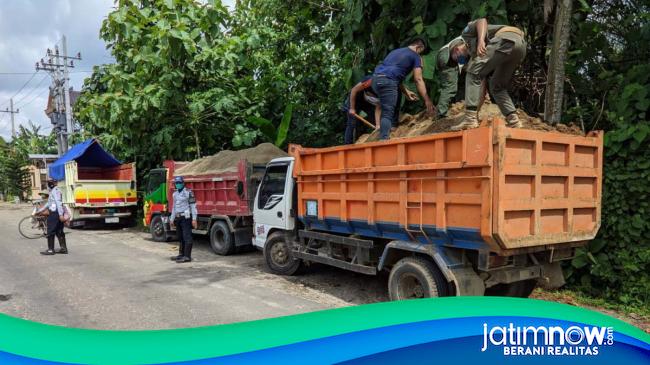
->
[372,38,435,139]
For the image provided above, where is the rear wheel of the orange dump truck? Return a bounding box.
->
[388,257,448,300]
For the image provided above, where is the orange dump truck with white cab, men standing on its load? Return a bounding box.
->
[253,120,603,300]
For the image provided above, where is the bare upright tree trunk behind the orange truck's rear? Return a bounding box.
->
[544,0,573,124]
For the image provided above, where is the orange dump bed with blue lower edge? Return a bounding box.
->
[289,120,603,255]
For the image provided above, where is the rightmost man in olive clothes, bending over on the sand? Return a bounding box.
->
[451,18,526,130]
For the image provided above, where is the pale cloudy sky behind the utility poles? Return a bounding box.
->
[0,0,234,140]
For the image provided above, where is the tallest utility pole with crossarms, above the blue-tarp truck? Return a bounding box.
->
[36,35,81,155]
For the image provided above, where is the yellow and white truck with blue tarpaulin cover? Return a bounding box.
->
[48,138,138,227]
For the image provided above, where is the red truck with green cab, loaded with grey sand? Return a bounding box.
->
[144,143,286,255]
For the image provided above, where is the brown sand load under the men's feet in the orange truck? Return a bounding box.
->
[356,100,584,143]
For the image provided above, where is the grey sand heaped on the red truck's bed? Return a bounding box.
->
[176,143,287,175]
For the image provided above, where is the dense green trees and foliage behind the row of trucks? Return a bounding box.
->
[76,0,650,304]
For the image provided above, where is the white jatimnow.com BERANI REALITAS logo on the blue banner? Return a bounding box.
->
[481,323,614,356]
